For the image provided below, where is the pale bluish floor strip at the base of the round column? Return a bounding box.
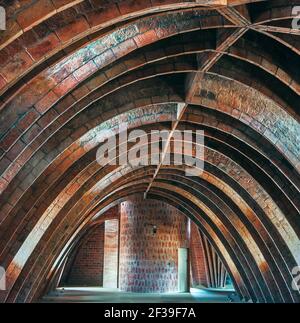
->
[42,288,239,303]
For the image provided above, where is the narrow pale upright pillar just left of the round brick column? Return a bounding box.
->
[103,219,119,288]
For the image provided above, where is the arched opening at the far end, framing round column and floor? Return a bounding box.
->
[48,200,241,303]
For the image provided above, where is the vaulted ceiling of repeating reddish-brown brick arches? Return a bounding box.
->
[0,0,300,302]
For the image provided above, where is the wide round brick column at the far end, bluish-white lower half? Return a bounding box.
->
[120,196,188,293]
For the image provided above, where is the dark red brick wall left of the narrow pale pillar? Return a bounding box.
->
[64,223,104,286]
